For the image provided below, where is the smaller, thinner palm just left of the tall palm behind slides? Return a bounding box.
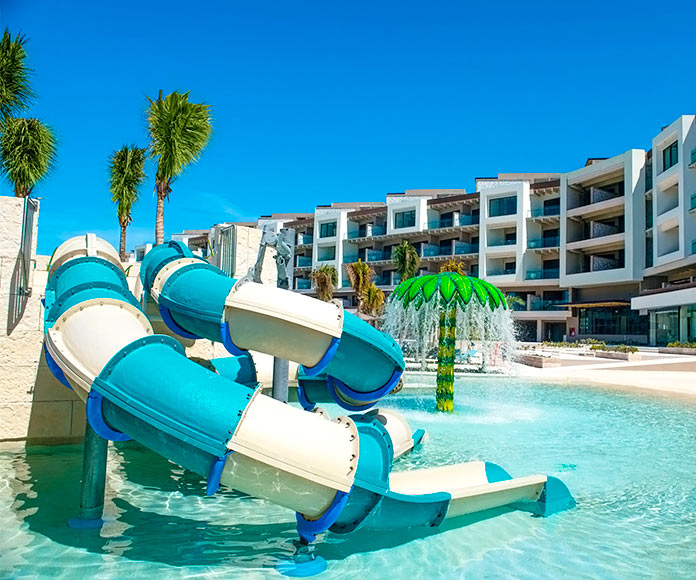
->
[109,145,147,262]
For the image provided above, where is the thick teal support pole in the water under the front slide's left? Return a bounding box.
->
[68,422,109,528]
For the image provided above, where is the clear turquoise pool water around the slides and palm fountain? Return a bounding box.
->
[0,377,696,580]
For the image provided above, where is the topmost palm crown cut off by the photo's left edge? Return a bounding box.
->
[0,29,34,122]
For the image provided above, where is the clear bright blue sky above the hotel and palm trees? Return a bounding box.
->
[0,0,696,253]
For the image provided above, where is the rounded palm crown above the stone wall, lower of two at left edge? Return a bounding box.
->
[0,117,56,197]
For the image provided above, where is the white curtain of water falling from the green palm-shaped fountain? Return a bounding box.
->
[383,292,517,372]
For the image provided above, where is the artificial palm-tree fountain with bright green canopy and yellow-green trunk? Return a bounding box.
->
[387,272,507,413]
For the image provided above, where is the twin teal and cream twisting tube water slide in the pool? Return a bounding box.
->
[45,234,575,542]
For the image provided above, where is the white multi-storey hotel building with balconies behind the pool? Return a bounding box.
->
[181,115,696,344]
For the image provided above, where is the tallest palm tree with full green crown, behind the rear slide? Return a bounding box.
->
[147,91,211,244]
